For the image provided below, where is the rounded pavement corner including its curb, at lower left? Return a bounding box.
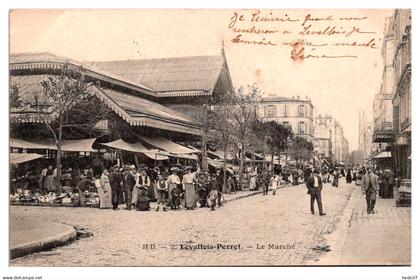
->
[9,217,76,259]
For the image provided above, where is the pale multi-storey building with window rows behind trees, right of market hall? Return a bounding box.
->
[257,96,314,141]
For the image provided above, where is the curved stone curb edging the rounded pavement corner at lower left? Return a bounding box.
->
[10,224,76,260]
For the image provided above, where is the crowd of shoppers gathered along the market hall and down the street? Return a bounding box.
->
[9,156,394,212]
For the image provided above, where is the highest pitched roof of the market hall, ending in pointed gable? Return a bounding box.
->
[91,55,225,96]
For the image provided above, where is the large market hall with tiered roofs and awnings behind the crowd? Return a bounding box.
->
[10,52,233,208]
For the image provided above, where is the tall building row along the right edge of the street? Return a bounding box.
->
[370,9,411,179]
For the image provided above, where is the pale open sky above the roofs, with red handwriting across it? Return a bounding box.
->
[10,9,392,151]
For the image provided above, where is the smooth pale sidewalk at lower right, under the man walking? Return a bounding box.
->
[318,187,411,265]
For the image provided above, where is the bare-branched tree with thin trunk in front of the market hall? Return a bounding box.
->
[27,65,109,183]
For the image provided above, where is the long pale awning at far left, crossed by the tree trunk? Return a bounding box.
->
[10,138,96,152]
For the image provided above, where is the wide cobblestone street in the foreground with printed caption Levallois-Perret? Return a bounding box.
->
[11,179,352,266]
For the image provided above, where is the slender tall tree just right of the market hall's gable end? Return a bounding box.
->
[232,84,261,187]
